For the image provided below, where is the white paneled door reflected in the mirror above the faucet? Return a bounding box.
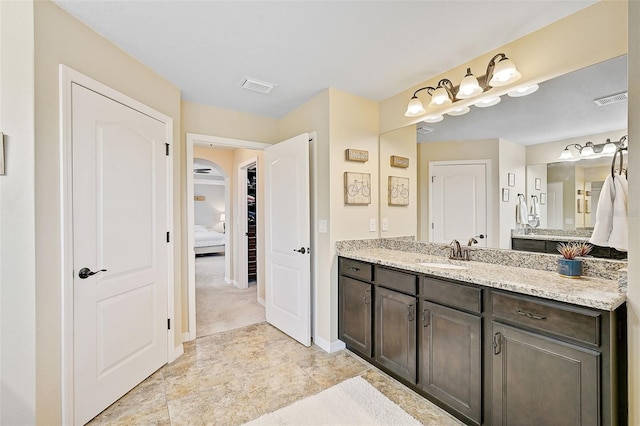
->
[429,163,488,247]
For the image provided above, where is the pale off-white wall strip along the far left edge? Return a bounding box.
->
[0,1,36,425]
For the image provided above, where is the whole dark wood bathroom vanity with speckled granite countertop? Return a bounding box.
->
[338,243,627,425]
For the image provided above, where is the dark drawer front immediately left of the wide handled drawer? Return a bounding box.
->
[422,277,482,314]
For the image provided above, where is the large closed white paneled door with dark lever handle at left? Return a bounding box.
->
[72,83,168,424]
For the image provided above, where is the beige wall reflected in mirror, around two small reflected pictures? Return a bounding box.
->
[379,126,418,237]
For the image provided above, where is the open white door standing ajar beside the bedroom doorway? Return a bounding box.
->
[265,133,311,346]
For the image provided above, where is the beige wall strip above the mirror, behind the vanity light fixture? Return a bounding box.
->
[380,1,627,133]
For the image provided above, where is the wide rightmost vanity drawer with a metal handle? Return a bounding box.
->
[493,292,601,346]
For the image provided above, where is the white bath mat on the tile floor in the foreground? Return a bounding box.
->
[246,377,421,426]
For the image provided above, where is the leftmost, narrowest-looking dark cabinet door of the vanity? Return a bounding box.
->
[338,276,373,357]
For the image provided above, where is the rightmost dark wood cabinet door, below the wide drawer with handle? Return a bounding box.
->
[492,322,600,426]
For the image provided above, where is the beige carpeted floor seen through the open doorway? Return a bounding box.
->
[196,254,266,337]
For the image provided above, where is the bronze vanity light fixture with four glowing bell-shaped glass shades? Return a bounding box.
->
[404,53,524,123]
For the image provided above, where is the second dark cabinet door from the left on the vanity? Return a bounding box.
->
[375,287,416,383]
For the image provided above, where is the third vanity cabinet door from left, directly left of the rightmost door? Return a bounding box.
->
[418,301,482,424]
